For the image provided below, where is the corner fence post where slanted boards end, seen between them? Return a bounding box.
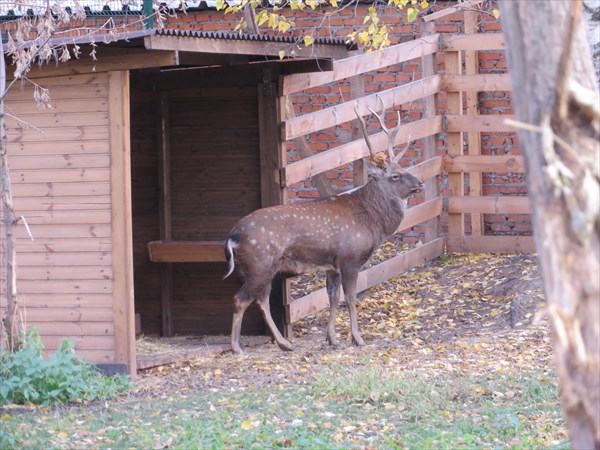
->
[421,22,440,242]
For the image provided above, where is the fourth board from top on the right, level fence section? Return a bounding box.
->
[444,155,526,173]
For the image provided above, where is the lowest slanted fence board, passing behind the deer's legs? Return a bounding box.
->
[286,238,444,323]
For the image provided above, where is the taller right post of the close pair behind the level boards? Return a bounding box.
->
[465,10,484,236]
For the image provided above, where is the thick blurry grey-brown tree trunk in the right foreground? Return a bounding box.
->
[501,0,600,449]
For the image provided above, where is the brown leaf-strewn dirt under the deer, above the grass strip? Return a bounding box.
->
[132,253,551,397]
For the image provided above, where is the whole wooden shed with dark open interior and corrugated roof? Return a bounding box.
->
[2,30,348,373]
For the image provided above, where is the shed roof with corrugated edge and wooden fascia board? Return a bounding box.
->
[3,29,356,77]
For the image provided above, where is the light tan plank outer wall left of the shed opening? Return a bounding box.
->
[2,73,115,363]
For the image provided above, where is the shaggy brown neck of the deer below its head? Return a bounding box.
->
[350,181,406,243]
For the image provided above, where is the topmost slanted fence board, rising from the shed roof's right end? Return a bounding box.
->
[281,34,440,95]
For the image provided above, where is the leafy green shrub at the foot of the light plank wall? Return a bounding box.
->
[0,328,129,405]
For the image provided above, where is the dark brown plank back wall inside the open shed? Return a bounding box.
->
[132,69,264,334]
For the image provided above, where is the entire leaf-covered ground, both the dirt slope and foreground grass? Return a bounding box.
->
[3,255,568,449]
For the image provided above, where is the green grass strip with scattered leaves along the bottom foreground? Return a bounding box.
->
[0,365,569,449]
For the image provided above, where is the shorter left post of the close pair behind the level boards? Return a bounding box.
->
[445,47,465,238]
